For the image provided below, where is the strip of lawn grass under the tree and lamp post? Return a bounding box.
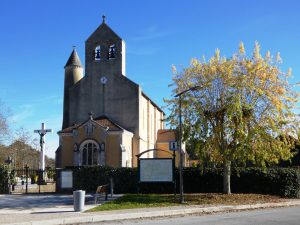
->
[87,193,284,212]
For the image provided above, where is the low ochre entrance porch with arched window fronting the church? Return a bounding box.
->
[56,114,133,168]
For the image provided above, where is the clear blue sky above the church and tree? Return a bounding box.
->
[0,0,300,157]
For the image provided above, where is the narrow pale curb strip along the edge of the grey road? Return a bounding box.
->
[10,200,300,225]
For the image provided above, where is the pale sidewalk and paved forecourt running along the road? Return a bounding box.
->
[0,195,300,225]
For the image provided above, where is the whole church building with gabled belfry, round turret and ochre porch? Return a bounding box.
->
[56,17,175,168]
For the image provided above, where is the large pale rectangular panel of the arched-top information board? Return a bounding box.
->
[140,159,173,182]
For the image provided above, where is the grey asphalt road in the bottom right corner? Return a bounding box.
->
[91,206,300,225]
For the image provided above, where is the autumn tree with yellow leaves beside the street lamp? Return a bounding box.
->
[165,42,299,194]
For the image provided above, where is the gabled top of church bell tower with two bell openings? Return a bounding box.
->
[85,16,125,77]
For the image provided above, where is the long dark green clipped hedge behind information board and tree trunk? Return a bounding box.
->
[73,167,300,197]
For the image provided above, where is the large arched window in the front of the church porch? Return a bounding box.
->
[80,140,99,166]
